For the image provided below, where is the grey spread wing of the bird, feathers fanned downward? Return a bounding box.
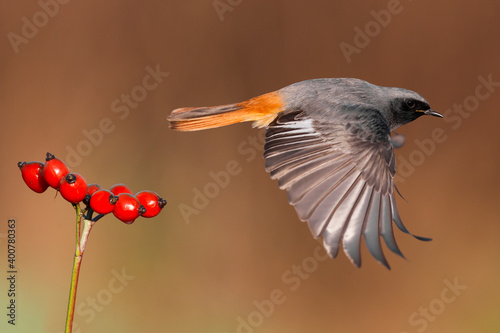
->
[264,110,428,268]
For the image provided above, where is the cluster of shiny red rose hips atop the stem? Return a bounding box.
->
[17,153,167,224]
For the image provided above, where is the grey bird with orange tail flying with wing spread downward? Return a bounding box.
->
[168,78,443,268]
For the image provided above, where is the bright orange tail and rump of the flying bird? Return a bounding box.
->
[167,92,285,131]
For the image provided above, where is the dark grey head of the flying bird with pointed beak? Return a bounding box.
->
[384,88,443,130]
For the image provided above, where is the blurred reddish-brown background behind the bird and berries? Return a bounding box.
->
[0,0,500,333]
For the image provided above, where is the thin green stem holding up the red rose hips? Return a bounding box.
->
[64,204,94,333]
